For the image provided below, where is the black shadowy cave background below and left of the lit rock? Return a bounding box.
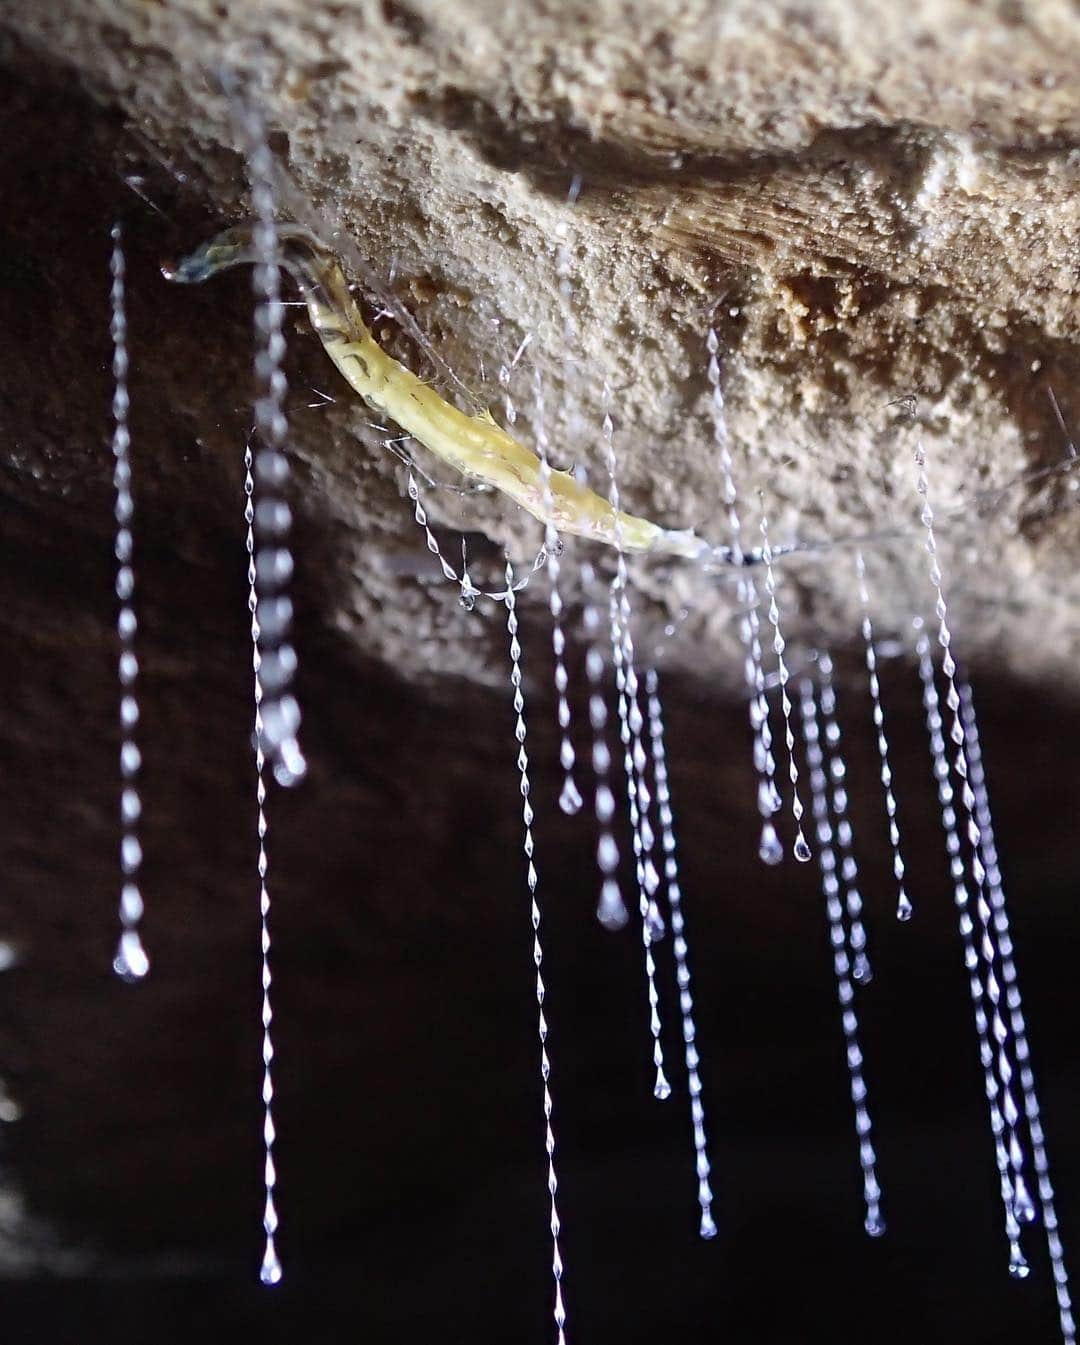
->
[0,57,1080,1345]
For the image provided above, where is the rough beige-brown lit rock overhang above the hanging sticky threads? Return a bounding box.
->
[5,0,1080,678]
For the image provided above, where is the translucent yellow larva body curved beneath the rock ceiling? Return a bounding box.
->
[165,225,710,558]
